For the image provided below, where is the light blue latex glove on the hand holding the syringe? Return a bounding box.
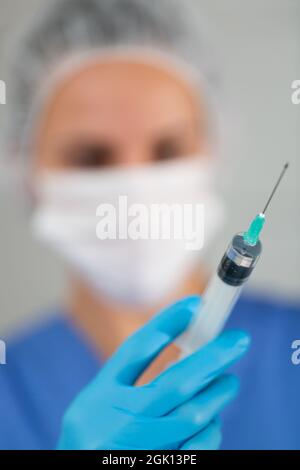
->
[58,296,250,450]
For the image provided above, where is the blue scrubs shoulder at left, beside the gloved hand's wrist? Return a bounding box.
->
[0,313,99,449]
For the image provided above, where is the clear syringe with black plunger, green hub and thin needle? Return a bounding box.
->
[176,163,289,357]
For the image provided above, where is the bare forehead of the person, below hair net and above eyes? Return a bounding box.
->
[37,60,201,138]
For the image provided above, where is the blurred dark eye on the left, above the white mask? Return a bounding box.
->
[63,144,115,168]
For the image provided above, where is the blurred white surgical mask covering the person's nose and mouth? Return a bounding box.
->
[33,157,223,306]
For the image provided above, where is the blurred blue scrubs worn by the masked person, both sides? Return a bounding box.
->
[0,297,300,449]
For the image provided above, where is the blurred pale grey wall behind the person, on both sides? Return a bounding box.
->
[0,0,300,336]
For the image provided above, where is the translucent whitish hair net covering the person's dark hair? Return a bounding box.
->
[5,0,223,158]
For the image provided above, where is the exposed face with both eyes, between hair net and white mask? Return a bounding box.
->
[35,61,207,170]
